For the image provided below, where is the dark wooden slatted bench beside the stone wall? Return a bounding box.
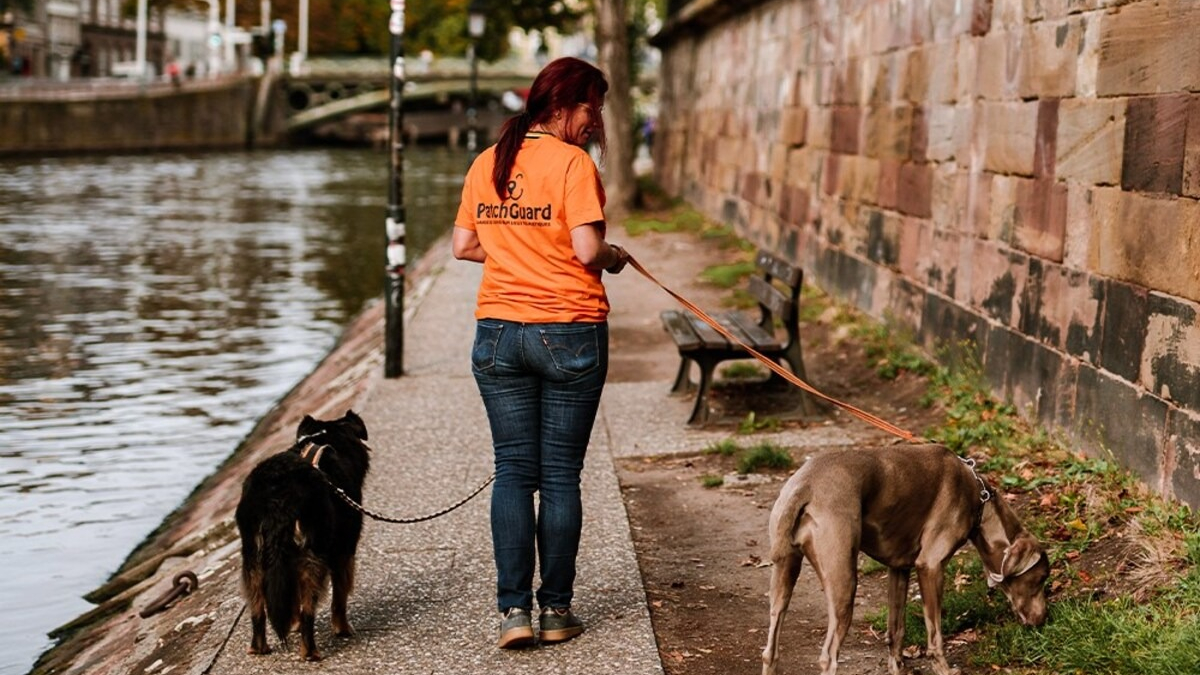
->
[661,251,811,425]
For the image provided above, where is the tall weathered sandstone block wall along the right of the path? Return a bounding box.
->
[655,0,1200,506]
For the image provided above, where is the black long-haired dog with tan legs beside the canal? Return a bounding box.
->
[238,411,371,661]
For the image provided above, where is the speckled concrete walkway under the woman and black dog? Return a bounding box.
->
[210,254,662,675]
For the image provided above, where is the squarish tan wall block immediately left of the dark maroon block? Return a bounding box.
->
[1055,98,1123,185]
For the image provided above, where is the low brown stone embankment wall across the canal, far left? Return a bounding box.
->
[0,79,284,156]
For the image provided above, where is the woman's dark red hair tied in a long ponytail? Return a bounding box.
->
[492,56,608,199]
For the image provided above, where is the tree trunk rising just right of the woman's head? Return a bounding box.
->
[595,0,637,220]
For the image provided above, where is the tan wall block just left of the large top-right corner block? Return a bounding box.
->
[1018,19,1084,98]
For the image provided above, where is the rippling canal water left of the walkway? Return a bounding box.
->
[0,148,468,675]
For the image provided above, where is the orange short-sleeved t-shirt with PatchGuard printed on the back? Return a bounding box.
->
[455,136,608,323]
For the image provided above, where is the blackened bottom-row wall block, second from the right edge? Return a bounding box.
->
[1073,368,1168,489]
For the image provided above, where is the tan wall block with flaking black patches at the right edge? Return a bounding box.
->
[1139,293,1200,412]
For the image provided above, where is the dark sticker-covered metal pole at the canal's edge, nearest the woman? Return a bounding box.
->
[383,0,407,377]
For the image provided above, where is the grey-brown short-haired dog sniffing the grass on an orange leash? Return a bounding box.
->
[762,444,1050,675]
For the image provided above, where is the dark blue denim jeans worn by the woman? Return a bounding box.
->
[470,318,608,611]
